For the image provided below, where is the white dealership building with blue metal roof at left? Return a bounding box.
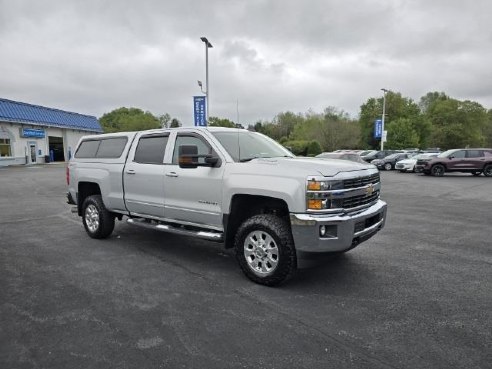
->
[0,98,102,167]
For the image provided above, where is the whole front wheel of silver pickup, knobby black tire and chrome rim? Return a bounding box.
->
[234,214,297,286]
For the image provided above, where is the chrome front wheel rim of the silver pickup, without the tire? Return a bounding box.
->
[244,231,279,277]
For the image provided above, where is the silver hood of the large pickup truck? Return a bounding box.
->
[246,157,377,177]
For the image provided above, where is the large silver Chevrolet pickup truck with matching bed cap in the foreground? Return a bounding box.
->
[67,127,386,286]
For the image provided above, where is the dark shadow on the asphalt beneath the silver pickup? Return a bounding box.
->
[110,218,373,294]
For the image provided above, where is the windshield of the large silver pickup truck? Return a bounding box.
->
[211,130,294,162]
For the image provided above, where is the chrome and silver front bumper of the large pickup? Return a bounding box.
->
[290,200,387,267]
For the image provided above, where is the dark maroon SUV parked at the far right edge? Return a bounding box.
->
[415,149,492,177]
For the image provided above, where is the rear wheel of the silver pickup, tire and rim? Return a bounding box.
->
[82,195,114,238]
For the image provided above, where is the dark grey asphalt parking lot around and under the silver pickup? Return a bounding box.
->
[0,164,492,369]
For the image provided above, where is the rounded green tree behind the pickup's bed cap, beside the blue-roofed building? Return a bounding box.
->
[99,107,161,133]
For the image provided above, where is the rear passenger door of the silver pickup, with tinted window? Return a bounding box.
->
[123,132,169,218]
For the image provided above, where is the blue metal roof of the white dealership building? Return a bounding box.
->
[0,98,103,132]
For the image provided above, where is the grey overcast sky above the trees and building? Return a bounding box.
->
[0,0,492,125]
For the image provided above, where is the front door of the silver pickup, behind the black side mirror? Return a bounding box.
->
[164,133,225,230]
